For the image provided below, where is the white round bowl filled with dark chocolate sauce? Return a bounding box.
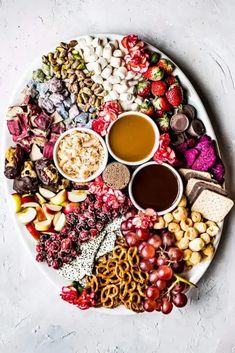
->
[129,161,183,215]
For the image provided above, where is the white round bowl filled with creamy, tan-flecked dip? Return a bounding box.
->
[53,127,108,182]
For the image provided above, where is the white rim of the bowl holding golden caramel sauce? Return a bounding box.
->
[105,110,160,166]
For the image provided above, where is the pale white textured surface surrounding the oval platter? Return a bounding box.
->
[0,0,235,353]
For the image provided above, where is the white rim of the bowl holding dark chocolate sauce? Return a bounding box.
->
[128,161,183,216]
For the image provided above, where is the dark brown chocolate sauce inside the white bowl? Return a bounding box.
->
[132,164,179,212]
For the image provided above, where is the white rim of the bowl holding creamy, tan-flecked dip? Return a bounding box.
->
[53,127,108,183]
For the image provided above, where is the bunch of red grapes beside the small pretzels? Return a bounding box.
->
[121,210,188,314]
